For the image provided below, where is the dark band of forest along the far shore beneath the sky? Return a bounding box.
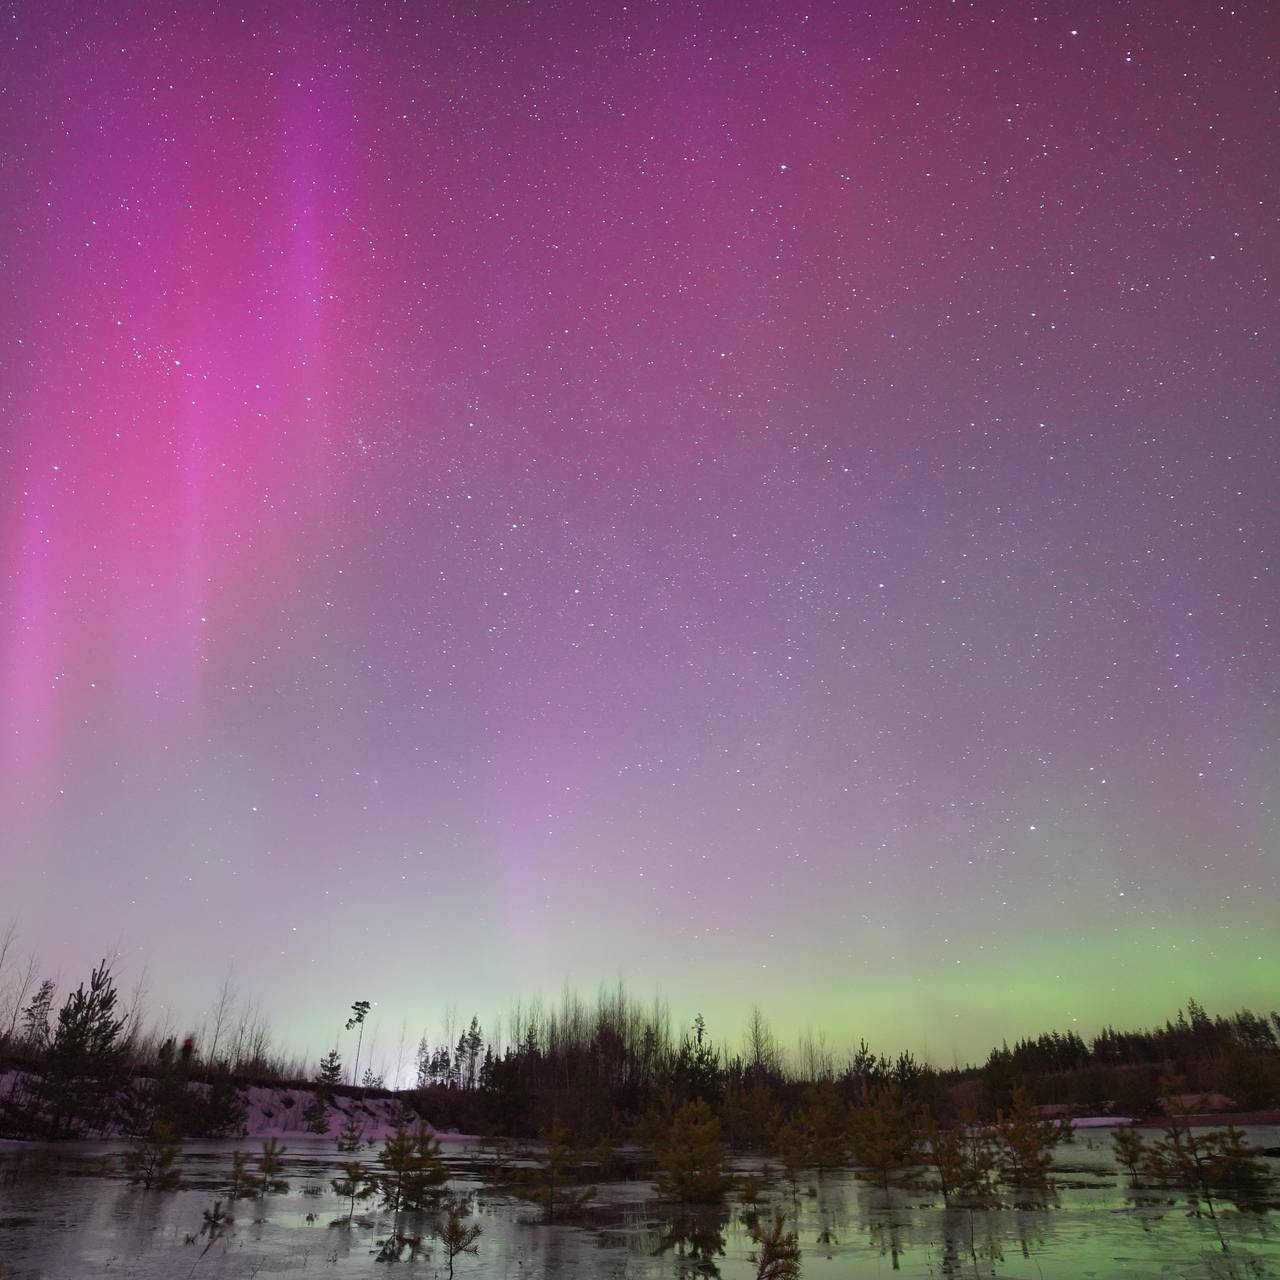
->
[0,926,1280,1153]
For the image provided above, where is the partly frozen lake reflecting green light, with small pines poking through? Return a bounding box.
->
[0,1128,1280,1280]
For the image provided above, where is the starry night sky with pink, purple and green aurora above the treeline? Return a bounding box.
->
[0,0,1280,1062]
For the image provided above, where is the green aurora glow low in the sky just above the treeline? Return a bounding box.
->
[257,925,1275,1069]
